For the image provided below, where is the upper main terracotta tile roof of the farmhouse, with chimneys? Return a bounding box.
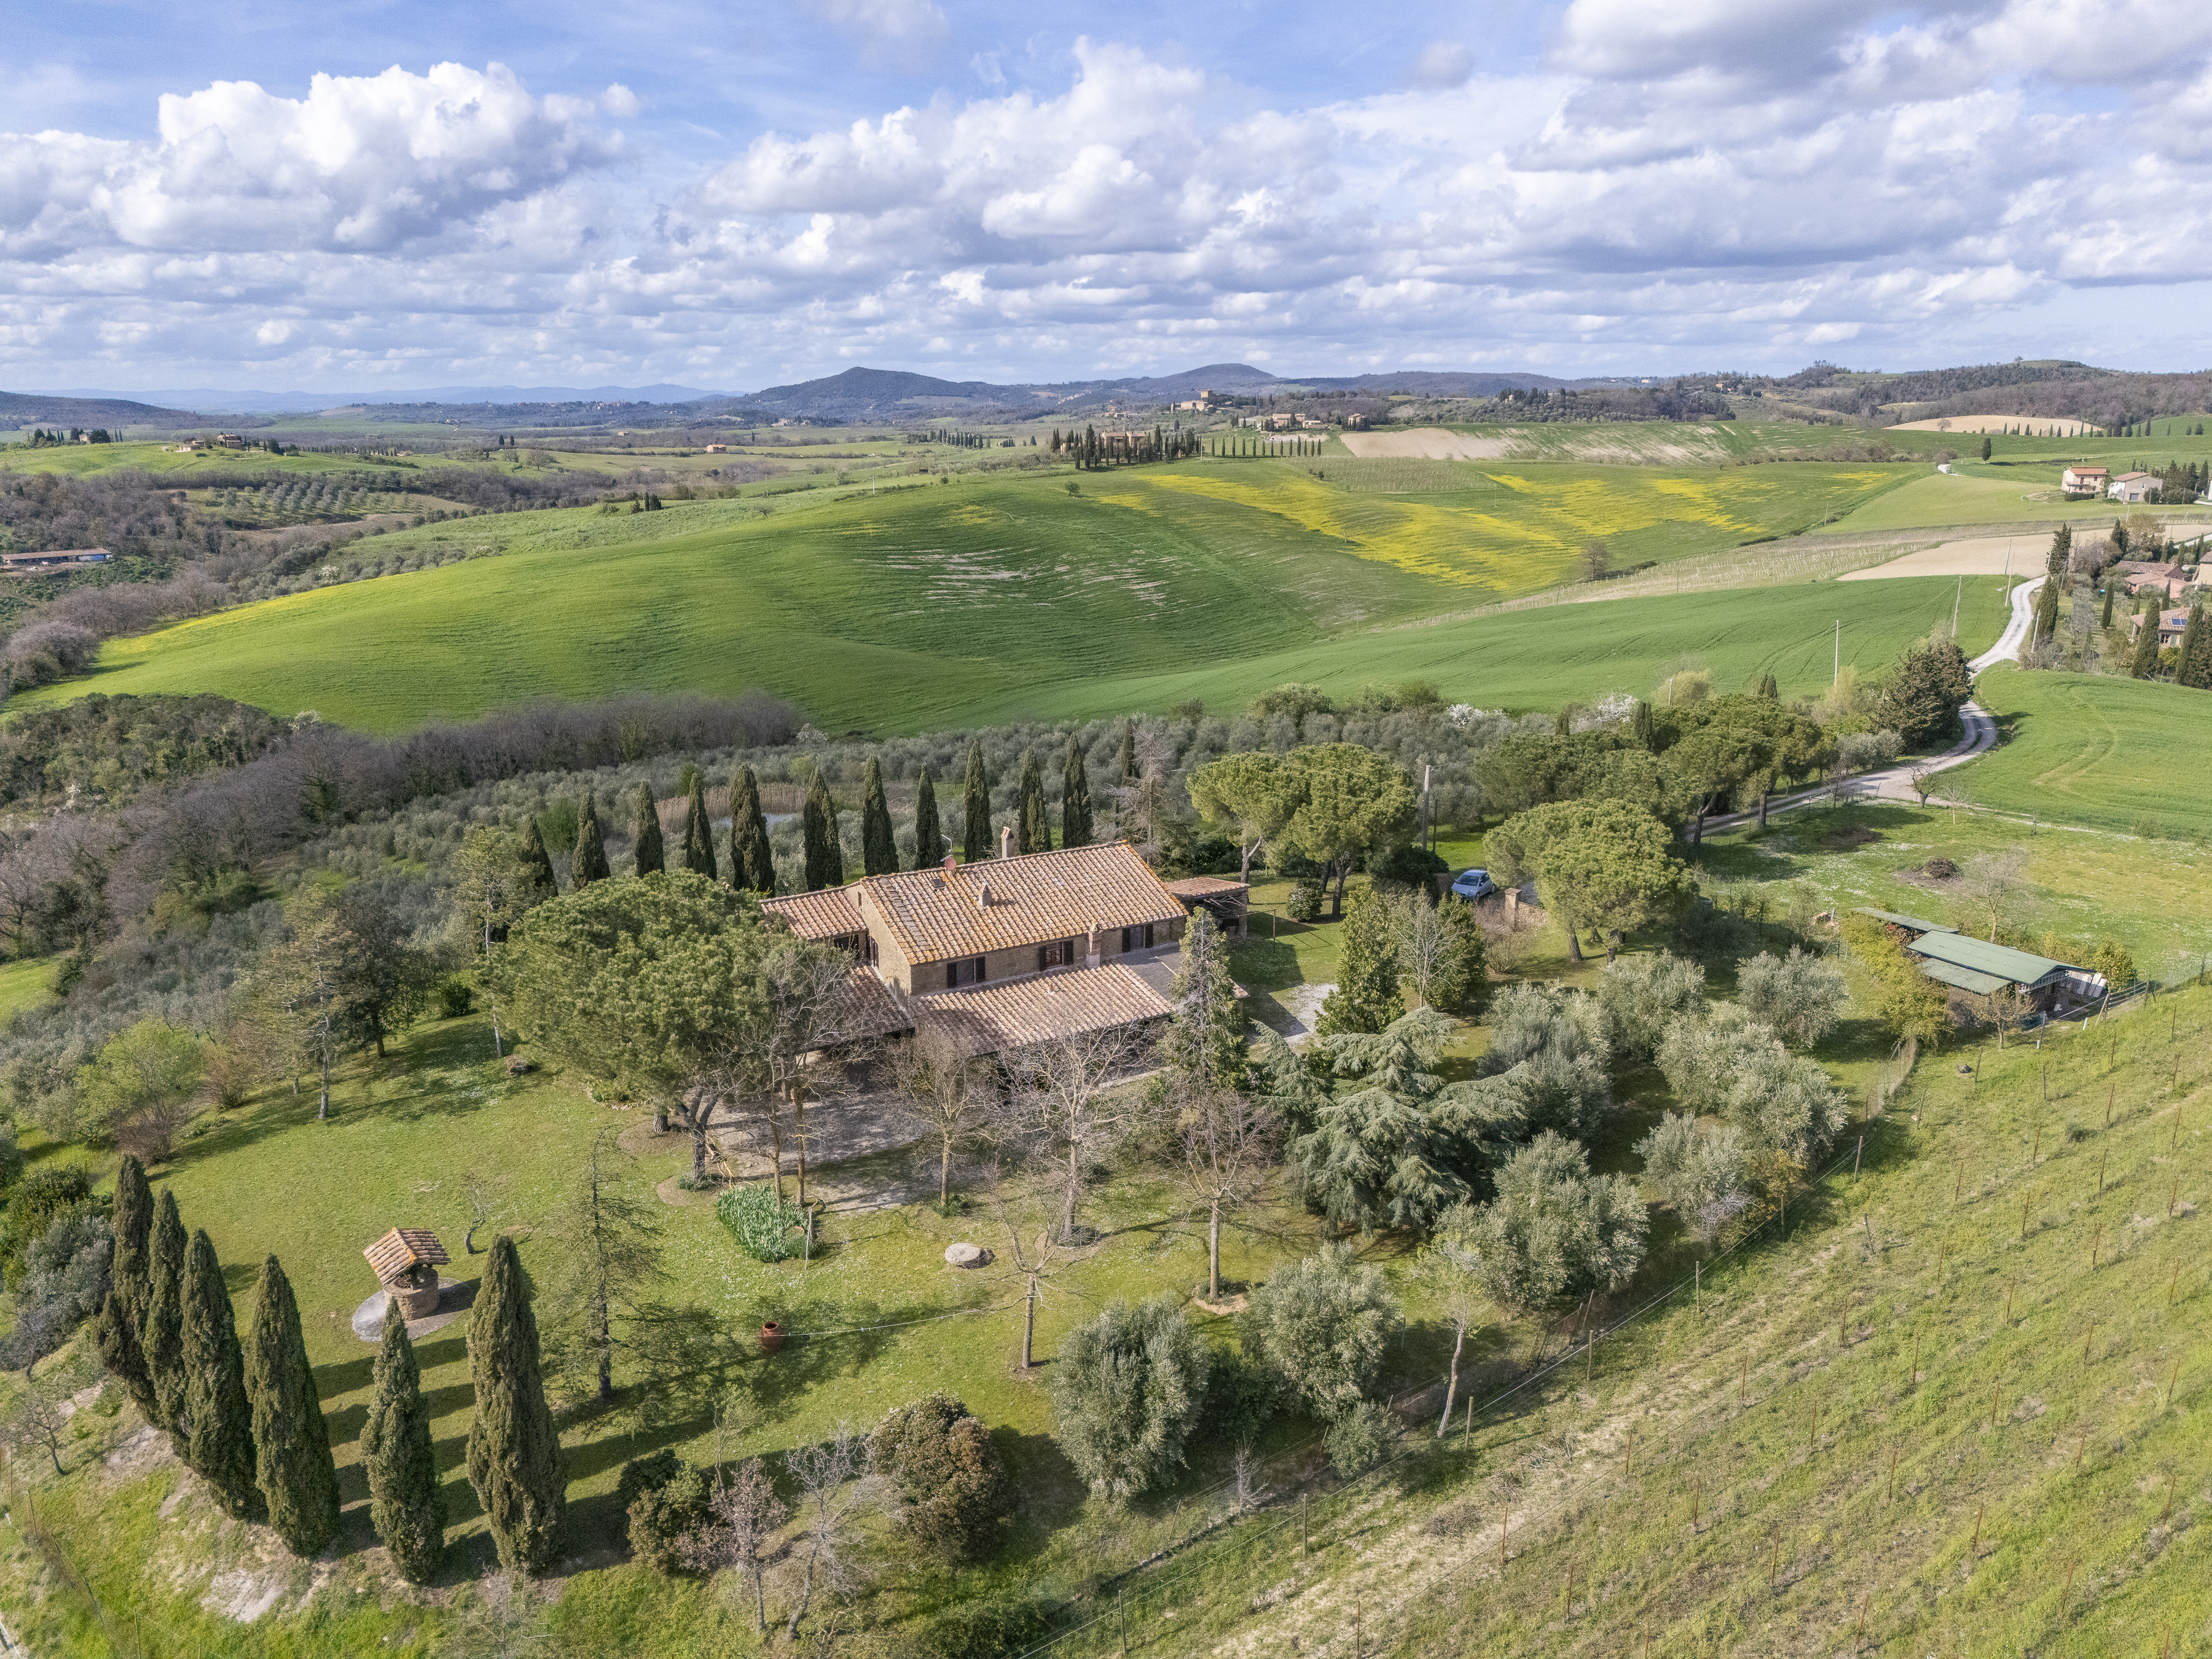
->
[858,841,1183,965]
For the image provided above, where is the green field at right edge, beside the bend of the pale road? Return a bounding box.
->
[1955,668,2212,836]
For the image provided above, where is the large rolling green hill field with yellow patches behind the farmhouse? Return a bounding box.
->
[4,462,1998,730]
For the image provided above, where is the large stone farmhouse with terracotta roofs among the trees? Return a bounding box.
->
[763,845,1245,1055]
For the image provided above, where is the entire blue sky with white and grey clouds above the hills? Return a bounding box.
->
[0,0,2212,391]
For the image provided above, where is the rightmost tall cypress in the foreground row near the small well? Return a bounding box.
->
[469,1234,568,1573]
